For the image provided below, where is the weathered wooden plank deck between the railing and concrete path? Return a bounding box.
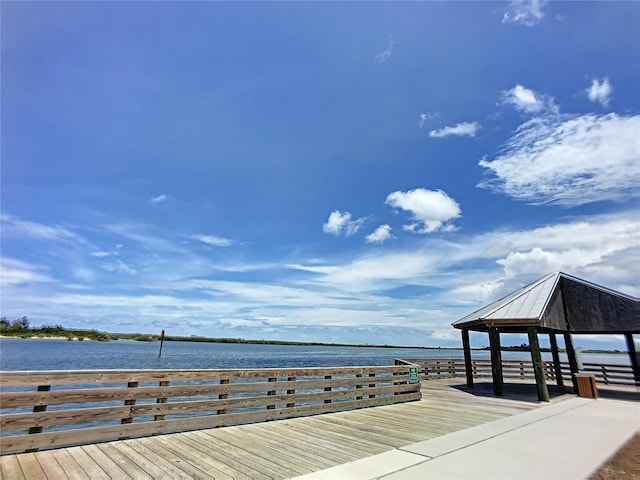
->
[0,379,566,480]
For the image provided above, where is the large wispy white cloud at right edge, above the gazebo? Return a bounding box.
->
[478,114,640,206]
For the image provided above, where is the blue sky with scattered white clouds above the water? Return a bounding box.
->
[1,1,640,348]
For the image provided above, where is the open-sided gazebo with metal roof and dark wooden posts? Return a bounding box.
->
[452,272,640,401]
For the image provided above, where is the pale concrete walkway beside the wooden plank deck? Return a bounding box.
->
[297,397,640,480]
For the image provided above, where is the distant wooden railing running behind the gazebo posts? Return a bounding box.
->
[396,358,638,386]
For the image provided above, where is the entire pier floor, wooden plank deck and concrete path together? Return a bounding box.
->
[0,379,640,480]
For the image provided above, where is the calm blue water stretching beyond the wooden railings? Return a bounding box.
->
[0,338,629,371]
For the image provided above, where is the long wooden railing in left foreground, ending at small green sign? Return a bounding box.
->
[0,365,421,454]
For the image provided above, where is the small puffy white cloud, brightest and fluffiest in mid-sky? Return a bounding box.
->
[386,188,460,233]
